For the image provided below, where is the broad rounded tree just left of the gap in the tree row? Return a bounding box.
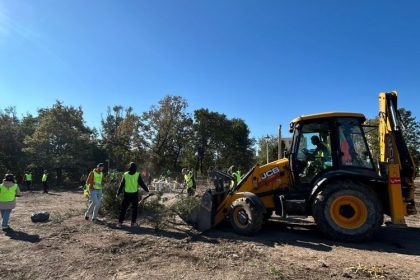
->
[23,101,96,184]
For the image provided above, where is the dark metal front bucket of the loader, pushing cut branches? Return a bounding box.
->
[181,191,214,232]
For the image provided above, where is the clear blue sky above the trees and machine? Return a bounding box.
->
[0,0,420,137]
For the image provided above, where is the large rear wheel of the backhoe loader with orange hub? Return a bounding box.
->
[312,180,384,242]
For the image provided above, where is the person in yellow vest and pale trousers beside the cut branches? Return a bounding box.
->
[85,163,104,223]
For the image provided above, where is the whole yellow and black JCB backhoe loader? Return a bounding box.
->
[188,92,416,242]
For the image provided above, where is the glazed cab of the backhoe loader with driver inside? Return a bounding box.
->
[289,113,376,191]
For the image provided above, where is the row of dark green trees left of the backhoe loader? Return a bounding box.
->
[0,96,255,183]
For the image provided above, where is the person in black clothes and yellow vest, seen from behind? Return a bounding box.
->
[116,162,149,228]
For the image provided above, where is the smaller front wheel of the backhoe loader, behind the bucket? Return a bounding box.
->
[229,198,264,236]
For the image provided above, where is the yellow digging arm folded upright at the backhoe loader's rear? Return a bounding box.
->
[379,92,417,225]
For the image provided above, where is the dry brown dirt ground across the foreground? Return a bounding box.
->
[0,182,420,280]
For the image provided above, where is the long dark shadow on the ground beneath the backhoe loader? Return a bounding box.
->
[95,215,420,256]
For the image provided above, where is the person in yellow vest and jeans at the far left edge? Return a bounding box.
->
[0,174,20,231]
